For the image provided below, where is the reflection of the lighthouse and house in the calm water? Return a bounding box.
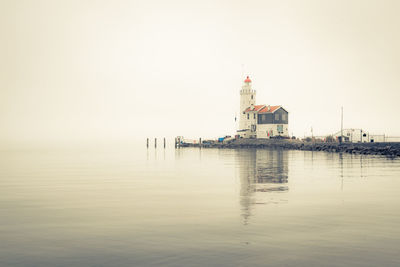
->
[236,149,289,224]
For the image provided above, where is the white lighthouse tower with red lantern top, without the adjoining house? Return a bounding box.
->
[238,76,256,136]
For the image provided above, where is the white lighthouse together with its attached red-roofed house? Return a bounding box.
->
[237,76,289,138]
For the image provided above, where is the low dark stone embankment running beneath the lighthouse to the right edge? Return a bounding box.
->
[203,139,400,157]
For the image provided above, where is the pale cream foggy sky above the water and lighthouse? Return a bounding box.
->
[0,0,400,148]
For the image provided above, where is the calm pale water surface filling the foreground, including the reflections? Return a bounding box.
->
[0,146,400,267]
